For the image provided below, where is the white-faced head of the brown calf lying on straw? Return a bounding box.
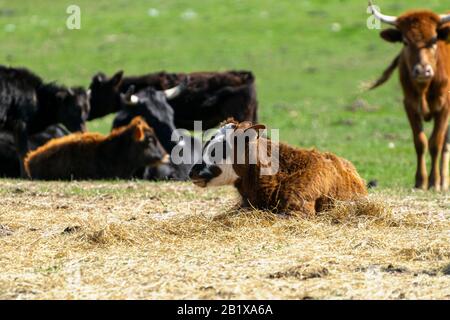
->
[189,121,265,187]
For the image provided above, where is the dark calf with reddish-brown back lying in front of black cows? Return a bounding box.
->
[25,117,168,180]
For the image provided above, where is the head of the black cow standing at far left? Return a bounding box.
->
[56,87,90,132]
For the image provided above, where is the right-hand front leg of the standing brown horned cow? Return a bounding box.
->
[428,109,448,191]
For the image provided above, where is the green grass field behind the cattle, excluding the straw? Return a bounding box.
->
[0,0,446,187]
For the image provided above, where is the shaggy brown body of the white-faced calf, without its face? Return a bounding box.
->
[233,125,367,215]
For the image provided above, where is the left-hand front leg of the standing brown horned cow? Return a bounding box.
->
[405,101,428,190]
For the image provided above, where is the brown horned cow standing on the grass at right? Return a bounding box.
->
[369,1,450,190]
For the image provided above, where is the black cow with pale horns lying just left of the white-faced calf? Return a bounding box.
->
[113,86,201,181]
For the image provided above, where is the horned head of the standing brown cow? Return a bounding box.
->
[369,1,450,84]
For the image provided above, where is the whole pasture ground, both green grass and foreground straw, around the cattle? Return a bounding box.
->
[0,0,450,299]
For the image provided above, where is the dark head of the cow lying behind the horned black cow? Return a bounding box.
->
[89,71,123,120]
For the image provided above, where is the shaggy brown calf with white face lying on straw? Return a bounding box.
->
[190,121,367,215]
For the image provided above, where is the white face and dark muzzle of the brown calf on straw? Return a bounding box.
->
[189,123,239,187]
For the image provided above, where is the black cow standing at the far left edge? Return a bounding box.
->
[0,66,89,174]
